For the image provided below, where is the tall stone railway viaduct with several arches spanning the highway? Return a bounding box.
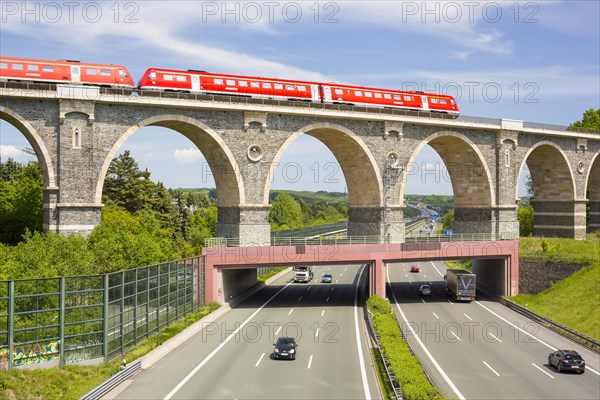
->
[0,83,600,245]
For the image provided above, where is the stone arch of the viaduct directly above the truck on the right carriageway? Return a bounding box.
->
[400,131,496,208]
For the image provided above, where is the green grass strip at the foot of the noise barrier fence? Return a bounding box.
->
[0,303,219,400]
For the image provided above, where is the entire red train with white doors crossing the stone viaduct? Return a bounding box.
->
[0,57,459,117]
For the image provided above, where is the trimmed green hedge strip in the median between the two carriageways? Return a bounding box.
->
[367,296,443,400]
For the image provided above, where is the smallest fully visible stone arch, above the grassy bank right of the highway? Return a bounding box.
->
[515,141,577,201]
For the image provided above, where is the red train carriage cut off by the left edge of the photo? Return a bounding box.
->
[0,57,135,89]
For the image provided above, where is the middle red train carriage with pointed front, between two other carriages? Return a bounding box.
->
[139,68,320,102]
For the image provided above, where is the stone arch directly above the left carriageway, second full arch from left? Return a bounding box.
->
[263,123,383,207]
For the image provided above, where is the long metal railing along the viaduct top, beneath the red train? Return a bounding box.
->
[0,82,600,134]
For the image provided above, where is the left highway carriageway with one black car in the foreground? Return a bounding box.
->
[115,265,380,399]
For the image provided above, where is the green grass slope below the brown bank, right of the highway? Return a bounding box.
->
[511,262,600,340]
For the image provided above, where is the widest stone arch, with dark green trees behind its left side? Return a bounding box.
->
[95,114,245,207]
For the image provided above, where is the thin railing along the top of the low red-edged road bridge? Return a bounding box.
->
[204,232,519,247]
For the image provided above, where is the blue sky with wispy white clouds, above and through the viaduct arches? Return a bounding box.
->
[0,0,600,194]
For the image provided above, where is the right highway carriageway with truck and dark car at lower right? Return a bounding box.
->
[387,262,600,399]
